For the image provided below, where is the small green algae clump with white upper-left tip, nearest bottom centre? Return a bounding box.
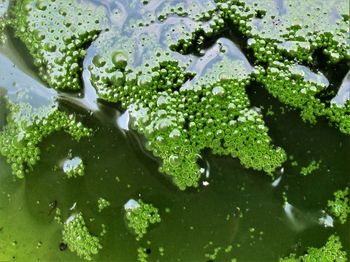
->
[124,199,161,240]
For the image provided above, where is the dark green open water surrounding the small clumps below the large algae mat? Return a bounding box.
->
[0,1,350,261]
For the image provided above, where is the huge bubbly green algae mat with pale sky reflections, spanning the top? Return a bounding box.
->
[4,0,350,189]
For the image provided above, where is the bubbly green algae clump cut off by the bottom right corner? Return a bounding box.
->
[280,235,348,262]
